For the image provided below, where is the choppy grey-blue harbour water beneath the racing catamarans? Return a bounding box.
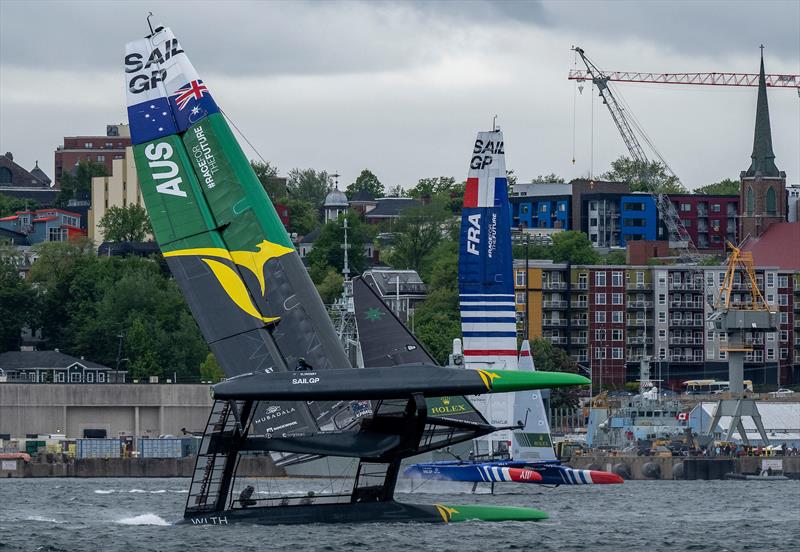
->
[0,478,800,552]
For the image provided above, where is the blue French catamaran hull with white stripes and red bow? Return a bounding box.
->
[405,462,623,485]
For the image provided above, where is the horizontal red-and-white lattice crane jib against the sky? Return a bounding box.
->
[567,69,800,95]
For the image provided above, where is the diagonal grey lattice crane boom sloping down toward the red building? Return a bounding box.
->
[572,46,702,264]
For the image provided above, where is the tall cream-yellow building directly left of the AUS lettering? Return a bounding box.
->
[88,147,143,245]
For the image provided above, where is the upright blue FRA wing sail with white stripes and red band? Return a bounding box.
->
[458,130,517,454]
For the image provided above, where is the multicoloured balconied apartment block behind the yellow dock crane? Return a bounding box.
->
[515,260,800,389]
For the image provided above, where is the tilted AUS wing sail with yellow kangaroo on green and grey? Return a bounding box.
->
[125,29,349,434]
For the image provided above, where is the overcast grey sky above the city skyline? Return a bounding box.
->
[0,0,800,188]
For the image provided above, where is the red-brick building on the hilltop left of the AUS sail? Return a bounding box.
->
[54,124,131,187]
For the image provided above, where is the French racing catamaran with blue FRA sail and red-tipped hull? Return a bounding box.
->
[404,129,622,485]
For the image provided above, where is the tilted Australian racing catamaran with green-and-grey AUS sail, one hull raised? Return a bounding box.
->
[124,20,588,525]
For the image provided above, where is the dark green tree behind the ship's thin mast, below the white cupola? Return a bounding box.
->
[308,211,372,284]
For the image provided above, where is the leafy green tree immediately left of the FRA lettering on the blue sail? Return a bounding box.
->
[389,201,450,272]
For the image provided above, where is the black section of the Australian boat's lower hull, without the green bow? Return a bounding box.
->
[177,501,445,525]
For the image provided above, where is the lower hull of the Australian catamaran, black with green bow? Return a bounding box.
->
[177,500,548,525]
